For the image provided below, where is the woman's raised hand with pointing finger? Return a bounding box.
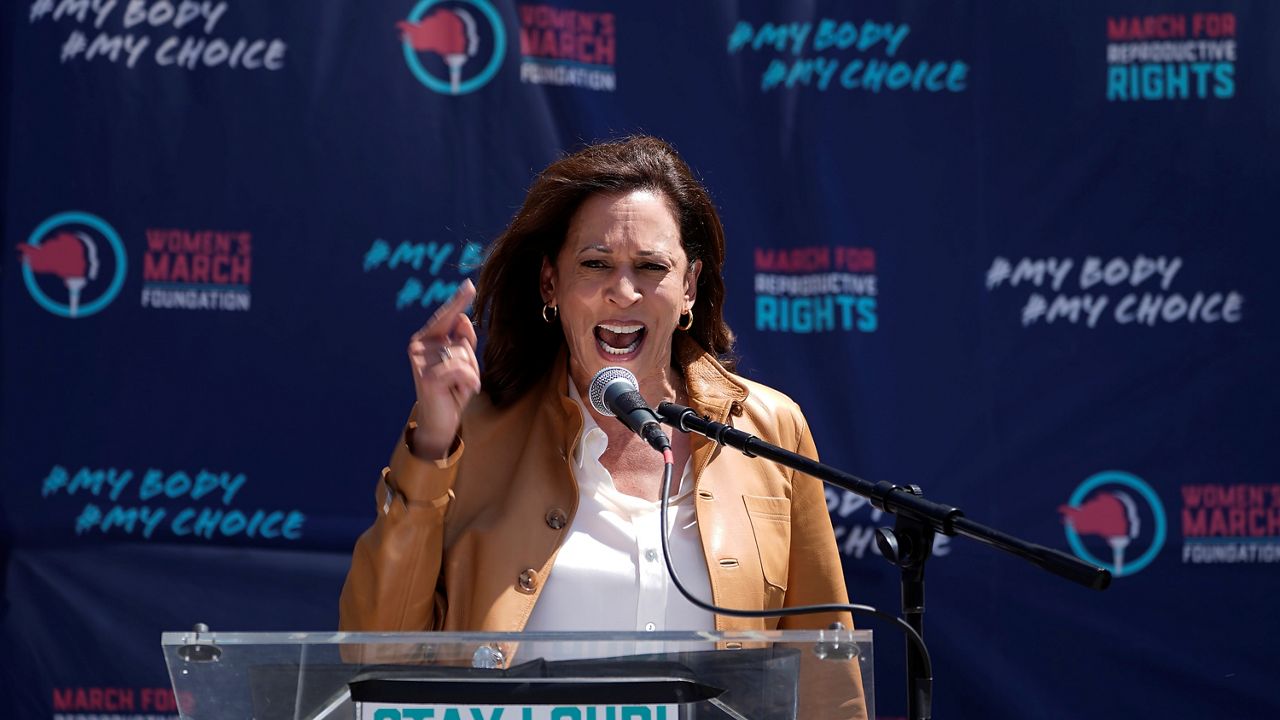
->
[408,279,480,460]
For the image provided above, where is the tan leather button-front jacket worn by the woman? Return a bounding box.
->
[340,341,852,632]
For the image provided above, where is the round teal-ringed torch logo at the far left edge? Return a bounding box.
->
[18,210,128,318]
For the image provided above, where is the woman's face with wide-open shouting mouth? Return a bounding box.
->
[541,190,701,391]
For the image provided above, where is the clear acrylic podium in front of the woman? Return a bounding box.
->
[161,628,876,720]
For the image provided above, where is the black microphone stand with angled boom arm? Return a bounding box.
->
[658,402,1111,719]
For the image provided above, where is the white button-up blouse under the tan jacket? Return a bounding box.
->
[525,380,716,632]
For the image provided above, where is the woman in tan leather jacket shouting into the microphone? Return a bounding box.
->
[340,137,852,681]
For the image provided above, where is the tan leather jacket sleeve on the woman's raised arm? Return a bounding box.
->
[338,421,463,632]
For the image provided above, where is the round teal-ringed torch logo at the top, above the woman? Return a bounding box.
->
[398,0,507,95]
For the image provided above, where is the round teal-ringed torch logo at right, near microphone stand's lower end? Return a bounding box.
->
[1059,470,1169,578]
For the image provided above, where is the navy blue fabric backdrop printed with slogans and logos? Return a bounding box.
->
[0,0,1280,719]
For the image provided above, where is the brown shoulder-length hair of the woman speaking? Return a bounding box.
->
[476,136,733,405]
